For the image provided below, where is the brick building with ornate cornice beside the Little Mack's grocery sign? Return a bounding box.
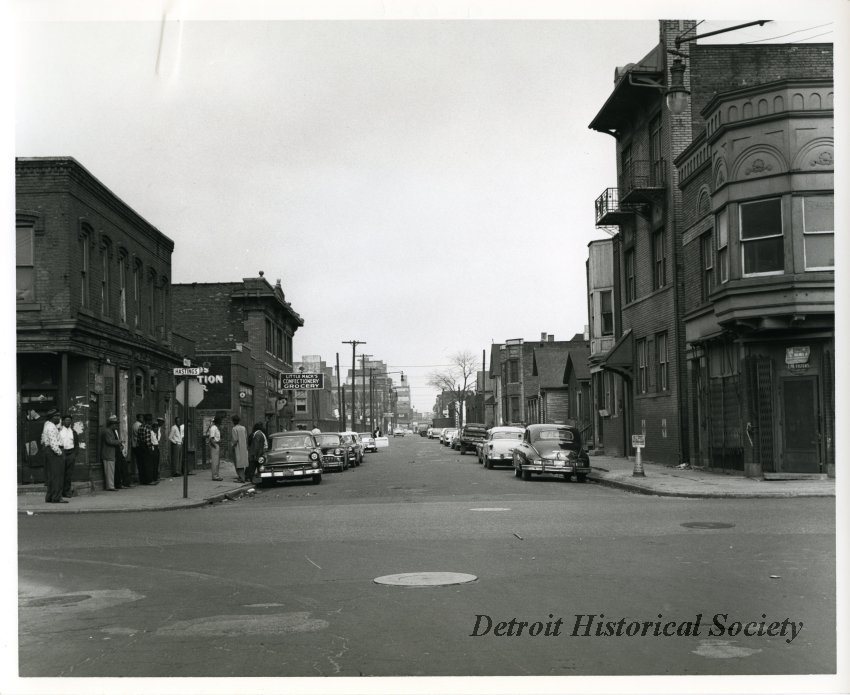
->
[171,271,304,448]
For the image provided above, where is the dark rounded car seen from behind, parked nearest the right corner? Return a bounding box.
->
[513,425,590,483]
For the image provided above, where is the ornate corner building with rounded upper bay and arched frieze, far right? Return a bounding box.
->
[676,75,835,478]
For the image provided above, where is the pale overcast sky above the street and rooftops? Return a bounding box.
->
[8,2,834,412]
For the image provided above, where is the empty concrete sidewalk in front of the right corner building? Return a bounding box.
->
[589,456,835,497]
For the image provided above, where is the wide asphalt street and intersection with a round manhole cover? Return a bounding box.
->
[18,436,836,676]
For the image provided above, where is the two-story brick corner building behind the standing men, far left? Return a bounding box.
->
[15,157,182,483]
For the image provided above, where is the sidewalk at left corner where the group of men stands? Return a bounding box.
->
[18,461,254,514]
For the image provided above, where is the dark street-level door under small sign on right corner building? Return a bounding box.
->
[782,376,822,473]
